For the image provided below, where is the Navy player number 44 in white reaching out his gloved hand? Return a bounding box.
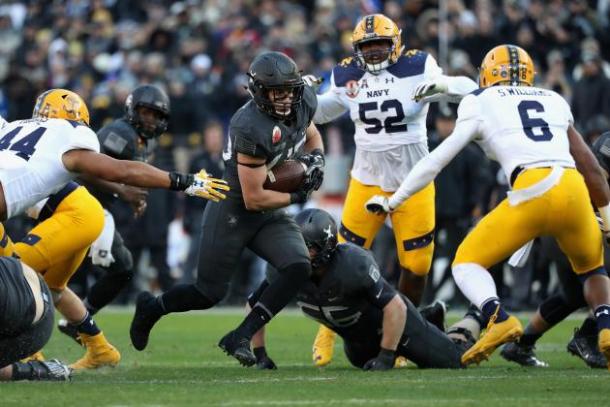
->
[0,89,228,369]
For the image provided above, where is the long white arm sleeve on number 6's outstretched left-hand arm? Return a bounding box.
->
[389,96,479,208]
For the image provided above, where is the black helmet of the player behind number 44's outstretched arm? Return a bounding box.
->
[125,85,169,139]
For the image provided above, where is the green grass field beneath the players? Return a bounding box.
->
[0,309,610,406]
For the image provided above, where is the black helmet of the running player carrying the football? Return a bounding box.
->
[248,52,305,119]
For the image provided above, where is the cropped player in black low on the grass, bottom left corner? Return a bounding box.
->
[0,257,72,381]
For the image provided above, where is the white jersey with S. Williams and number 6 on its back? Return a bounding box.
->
[458,86,575,179]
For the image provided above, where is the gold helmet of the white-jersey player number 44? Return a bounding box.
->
[32,89,89,126]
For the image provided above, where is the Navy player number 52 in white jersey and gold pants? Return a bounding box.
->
[306,14,477,366]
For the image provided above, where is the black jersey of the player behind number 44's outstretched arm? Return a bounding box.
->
[87,118,154,207]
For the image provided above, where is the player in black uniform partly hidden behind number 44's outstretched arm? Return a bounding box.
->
[59,85,176,341]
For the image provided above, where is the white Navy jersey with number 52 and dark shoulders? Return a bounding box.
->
[314,50,476,192]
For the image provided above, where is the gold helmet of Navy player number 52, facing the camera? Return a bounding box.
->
[352,14,403,74]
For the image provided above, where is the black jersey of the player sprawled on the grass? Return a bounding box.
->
[297,243,397,343]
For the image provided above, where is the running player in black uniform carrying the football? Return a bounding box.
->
[130,52,324,365]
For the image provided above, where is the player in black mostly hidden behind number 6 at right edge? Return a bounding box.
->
[501,132,610,369]
